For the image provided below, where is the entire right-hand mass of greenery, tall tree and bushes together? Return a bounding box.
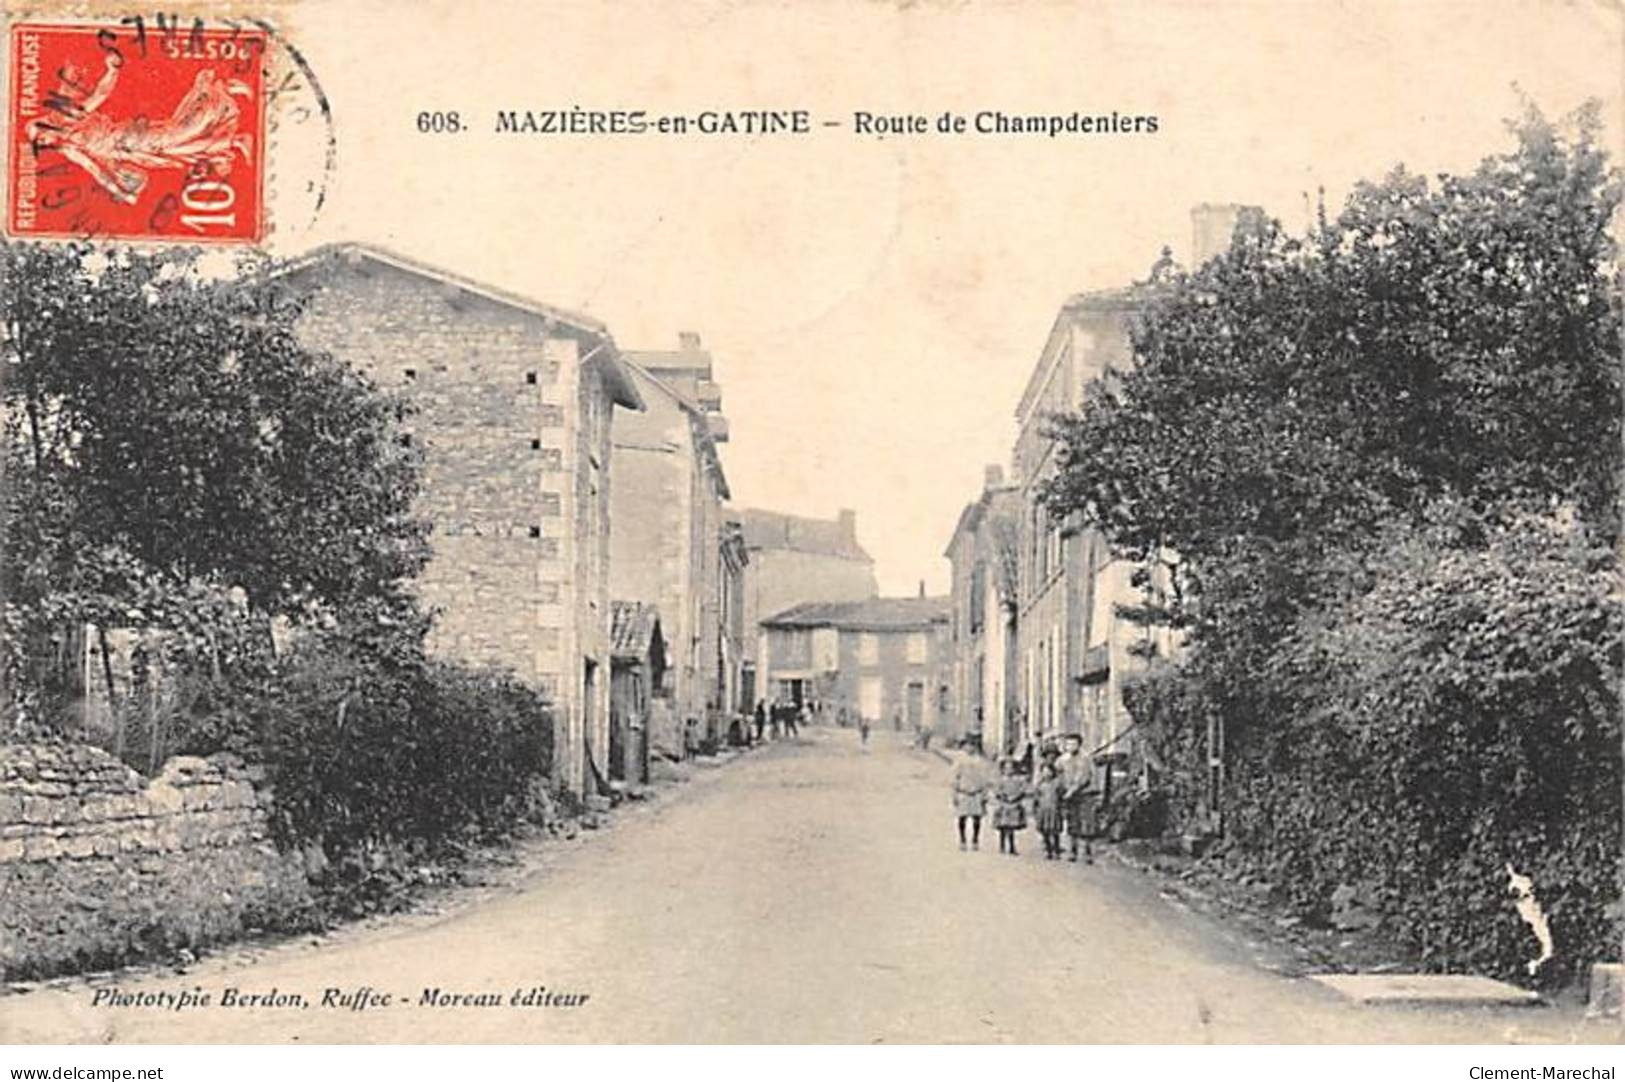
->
[1048,112,1622,978]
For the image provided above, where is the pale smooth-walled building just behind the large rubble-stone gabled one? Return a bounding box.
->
[609,346,738,752]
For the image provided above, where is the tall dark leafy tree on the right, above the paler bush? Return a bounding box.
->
[1048,110,1622,614]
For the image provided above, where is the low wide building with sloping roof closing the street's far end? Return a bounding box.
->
[761,595,951,731]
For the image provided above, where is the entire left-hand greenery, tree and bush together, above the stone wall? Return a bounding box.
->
[0,245,553,910]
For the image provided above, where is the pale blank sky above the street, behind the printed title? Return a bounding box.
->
[276,2,1622,593]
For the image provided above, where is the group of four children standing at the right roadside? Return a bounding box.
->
[954,733,1100,864]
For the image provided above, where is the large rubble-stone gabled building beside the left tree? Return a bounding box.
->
[281,244,642,793]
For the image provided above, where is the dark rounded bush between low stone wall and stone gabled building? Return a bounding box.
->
[185,610,553,911]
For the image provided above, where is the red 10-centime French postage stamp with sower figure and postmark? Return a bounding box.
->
[7,19,267,244]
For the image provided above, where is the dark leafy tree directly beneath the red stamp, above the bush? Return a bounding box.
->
[0,244,427,734]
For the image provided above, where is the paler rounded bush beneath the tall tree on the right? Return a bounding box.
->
[1131,518,1625,985]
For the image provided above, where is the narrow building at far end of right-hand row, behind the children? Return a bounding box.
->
[943,466,1021,749]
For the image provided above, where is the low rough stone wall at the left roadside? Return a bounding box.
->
[0,744,310,980]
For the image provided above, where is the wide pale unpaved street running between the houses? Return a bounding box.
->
[0,729,1617,1043]
